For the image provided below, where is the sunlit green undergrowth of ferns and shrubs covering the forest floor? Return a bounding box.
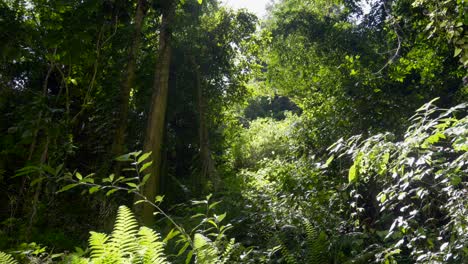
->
[0,102,468,263]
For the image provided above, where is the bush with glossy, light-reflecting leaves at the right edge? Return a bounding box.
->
[330,100,468,263]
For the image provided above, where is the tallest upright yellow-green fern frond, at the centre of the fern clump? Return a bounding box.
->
[110,206,138,258]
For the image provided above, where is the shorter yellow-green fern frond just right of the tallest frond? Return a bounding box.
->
[138,227,169,264]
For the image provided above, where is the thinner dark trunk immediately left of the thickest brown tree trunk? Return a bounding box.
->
[108,0,148,175]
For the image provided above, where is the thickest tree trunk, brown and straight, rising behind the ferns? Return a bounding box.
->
[142,1,175,225]
